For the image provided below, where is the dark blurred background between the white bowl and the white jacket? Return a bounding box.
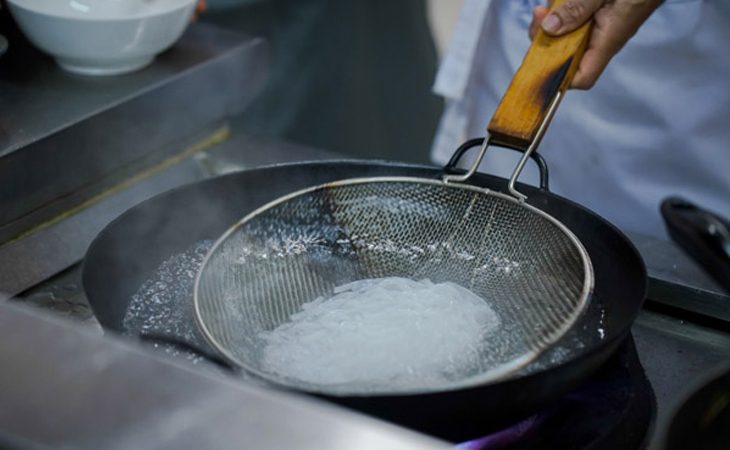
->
[200,0,461,162]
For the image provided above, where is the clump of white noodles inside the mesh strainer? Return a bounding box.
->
[260,277,500,390]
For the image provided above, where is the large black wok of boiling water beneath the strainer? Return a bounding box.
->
[83,140,646,441]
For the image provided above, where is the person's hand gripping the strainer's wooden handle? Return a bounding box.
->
[530,0,663,89]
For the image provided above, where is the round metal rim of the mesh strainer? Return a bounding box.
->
[193,176,595,396]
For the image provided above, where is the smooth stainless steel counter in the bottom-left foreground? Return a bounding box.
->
[0,298,449,450]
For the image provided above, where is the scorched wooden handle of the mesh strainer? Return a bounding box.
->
[487,0,592,149]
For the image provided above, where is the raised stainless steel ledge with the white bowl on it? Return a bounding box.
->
[0,20,267,243]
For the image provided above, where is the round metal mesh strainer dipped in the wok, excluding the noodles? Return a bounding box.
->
[194,7,593,394]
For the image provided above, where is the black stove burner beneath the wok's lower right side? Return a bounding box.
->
[457,337,656,450]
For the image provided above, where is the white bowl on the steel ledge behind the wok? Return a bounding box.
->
[7,0,197,75]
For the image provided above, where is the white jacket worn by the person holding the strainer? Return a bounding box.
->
[432,0,730,237]
